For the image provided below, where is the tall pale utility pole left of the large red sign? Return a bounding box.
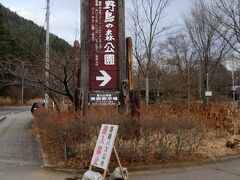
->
[45,0,50,107]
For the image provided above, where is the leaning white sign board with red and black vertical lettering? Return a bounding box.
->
[91,124,118,170]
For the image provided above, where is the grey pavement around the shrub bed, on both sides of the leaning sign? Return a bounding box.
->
[0,111,240,180]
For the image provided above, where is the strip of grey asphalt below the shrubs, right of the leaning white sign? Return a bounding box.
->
[130,159,240,180]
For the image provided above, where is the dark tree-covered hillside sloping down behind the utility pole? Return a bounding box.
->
[0,3,72,61]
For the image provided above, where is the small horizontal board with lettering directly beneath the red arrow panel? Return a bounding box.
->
[89,91,119,106]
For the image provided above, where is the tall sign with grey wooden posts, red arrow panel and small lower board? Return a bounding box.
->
[80,0,127,112]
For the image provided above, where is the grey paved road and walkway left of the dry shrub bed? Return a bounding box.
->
[0,109,76,180]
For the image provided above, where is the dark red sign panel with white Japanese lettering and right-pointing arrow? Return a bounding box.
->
[88,0,119,91]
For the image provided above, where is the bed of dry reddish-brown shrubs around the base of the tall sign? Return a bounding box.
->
[32,103,240,168]
